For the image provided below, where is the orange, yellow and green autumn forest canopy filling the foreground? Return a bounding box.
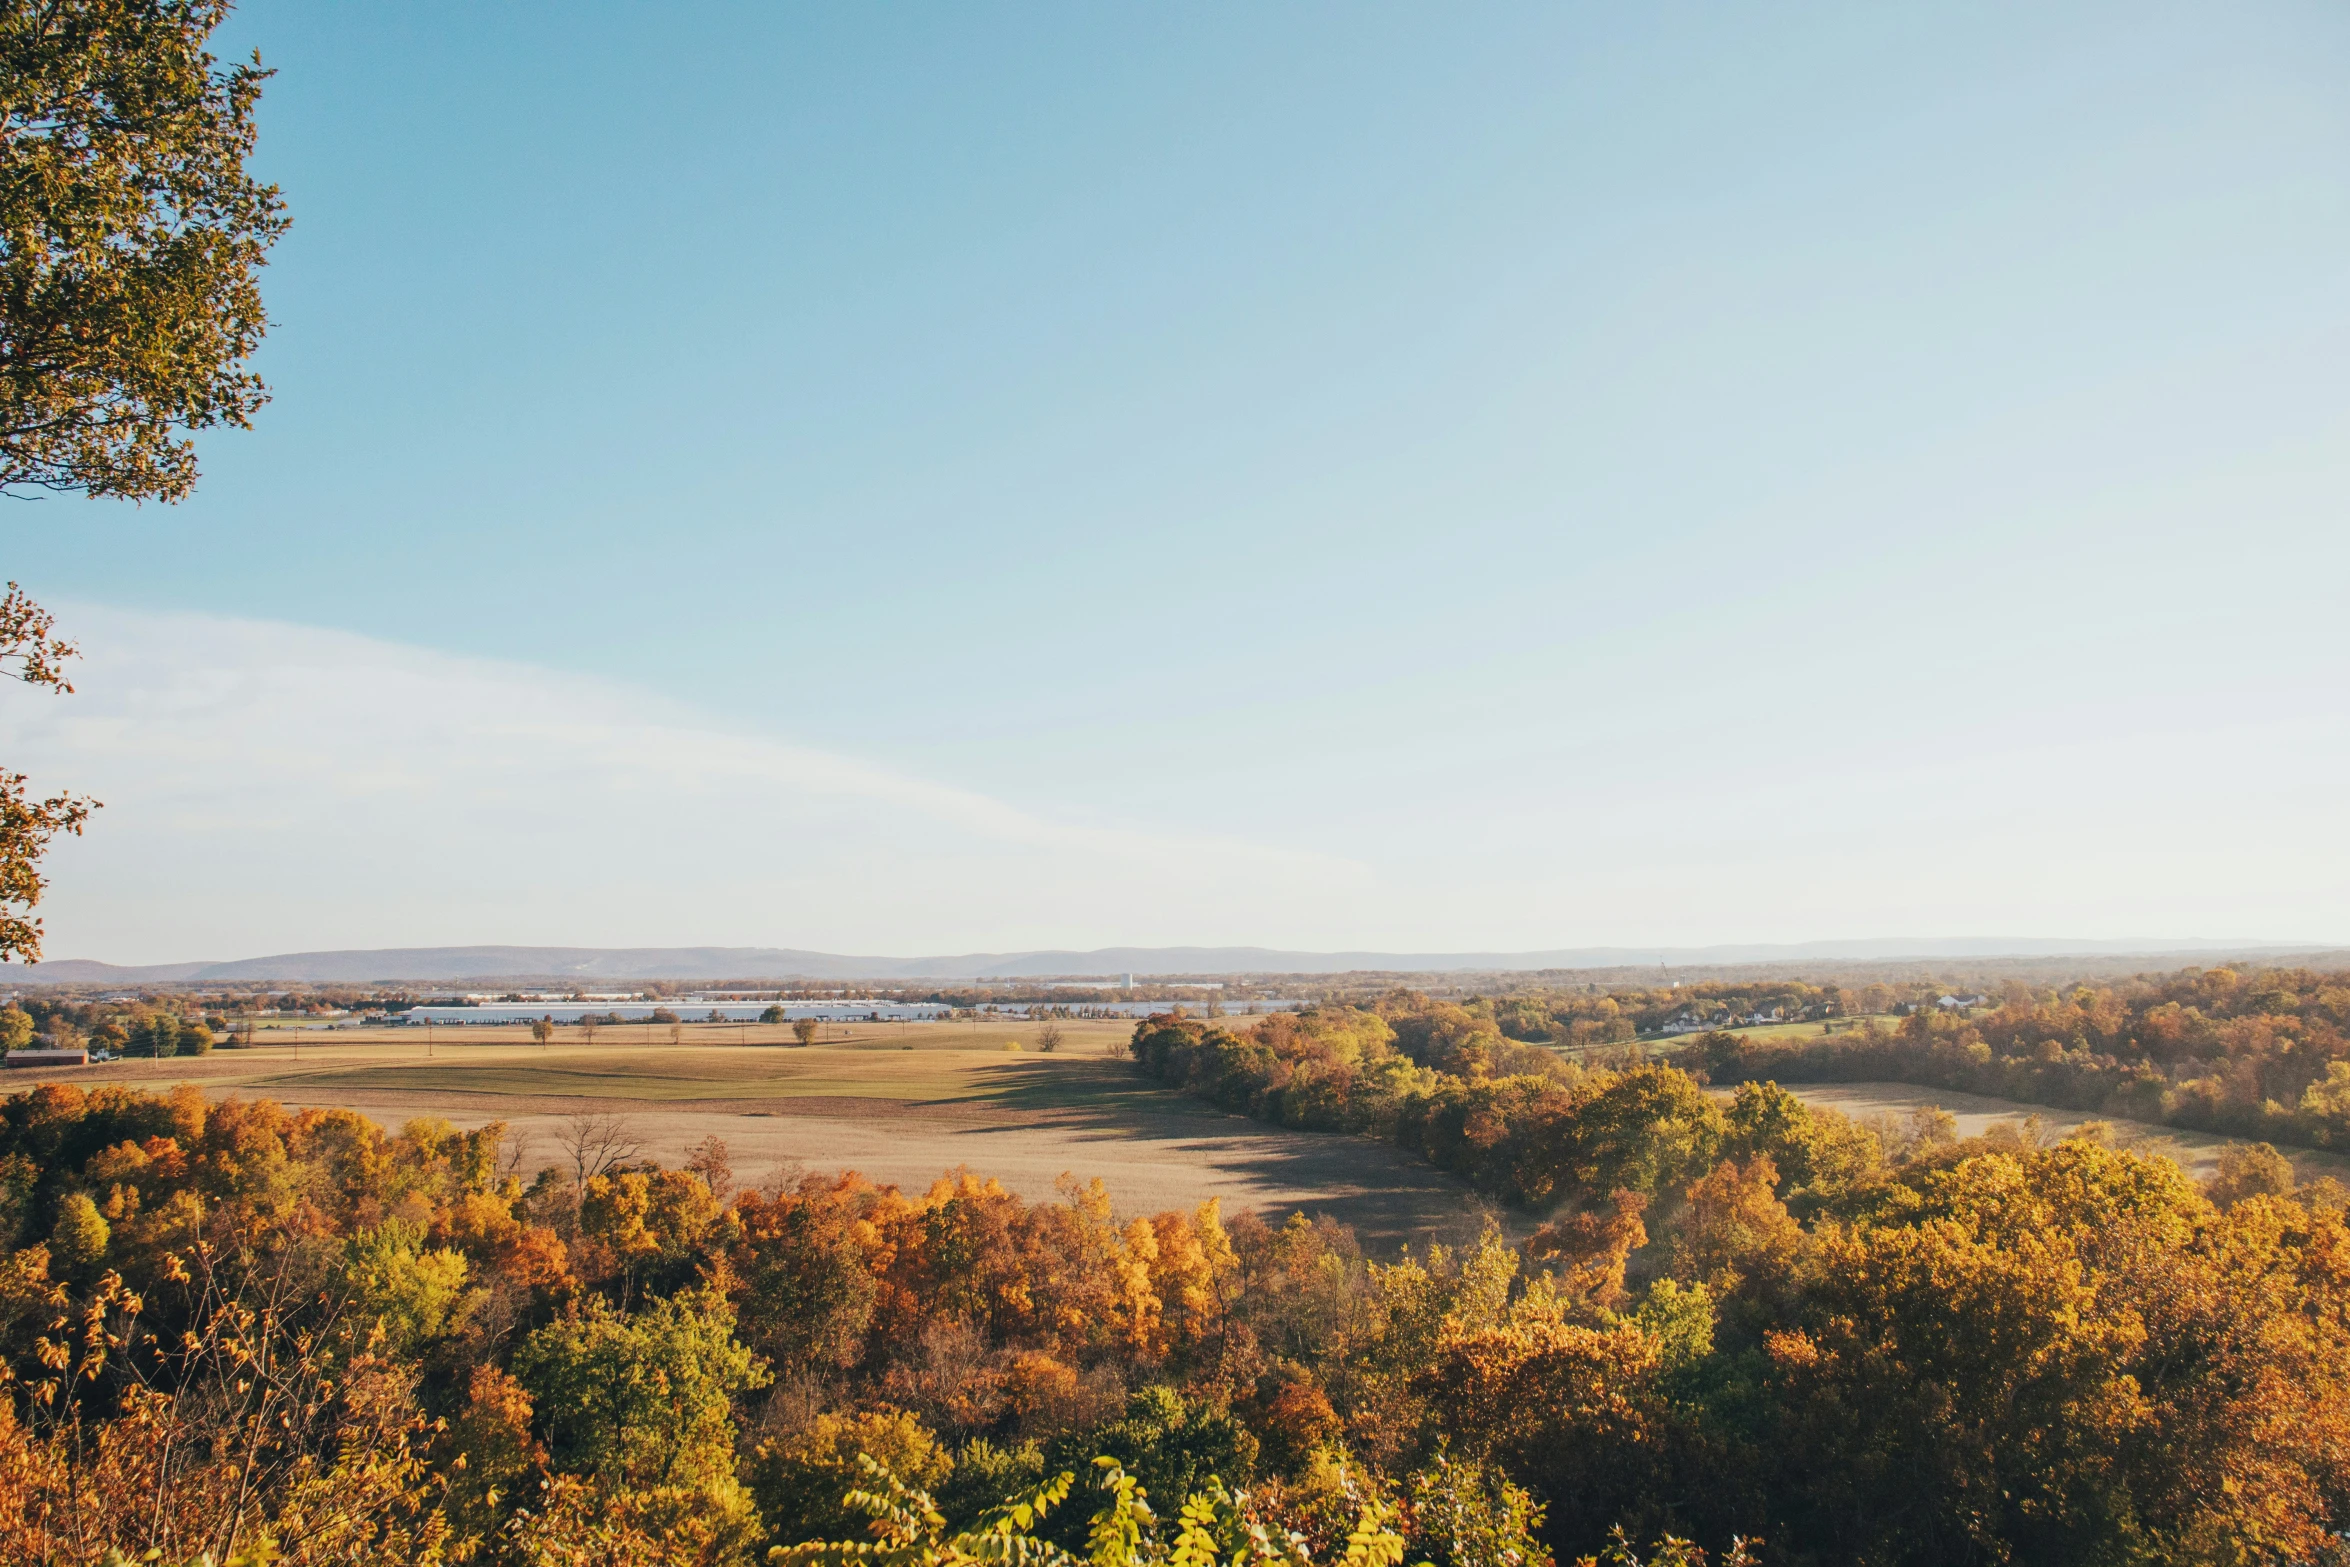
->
[0,1001,2350,1567]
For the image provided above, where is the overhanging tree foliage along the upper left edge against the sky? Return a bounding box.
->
[0,0,287,961]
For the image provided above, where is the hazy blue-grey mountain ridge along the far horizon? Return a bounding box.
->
[0,935,2329,984]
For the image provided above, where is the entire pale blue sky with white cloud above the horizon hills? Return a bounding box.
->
[0,0,2350,961]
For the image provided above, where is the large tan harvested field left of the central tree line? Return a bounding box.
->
[0,1022,1485,1250]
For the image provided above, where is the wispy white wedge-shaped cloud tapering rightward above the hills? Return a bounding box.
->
[0,604,1368,961]
